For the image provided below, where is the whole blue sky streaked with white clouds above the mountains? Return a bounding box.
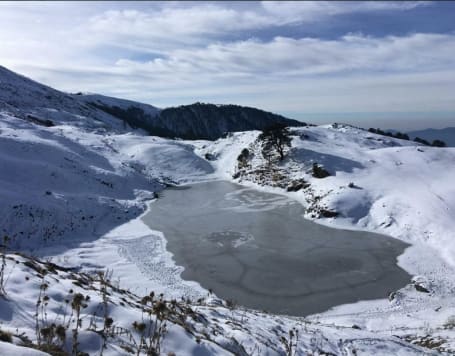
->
[0,1,455,130]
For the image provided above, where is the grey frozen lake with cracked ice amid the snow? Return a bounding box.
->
[143,181,410,315]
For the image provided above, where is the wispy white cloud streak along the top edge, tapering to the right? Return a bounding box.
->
[83,1,430,47]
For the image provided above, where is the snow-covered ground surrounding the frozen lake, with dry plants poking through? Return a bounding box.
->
[0,108,455,355]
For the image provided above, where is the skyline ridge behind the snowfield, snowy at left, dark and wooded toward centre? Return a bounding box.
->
[0,66,304,140]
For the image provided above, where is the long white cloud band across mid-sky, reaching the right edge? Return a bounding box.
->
[112,34,455,79]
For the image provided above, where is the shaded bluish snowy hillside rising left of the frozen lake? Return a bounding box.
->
[0,113,213,249]
